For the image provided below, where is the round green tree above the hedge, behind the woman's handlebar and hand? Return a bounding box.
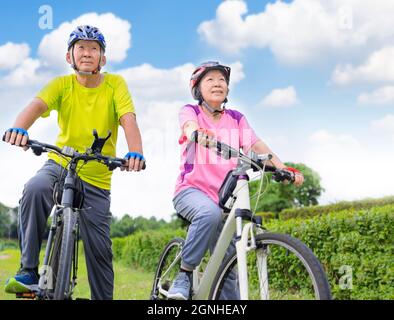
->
[250,162,324,213]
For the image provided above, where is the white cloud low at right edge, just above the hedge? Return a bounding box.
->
[305,130,394,203]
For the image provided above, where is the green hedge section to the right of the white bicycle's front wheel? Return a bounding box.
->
[267,205,394,299]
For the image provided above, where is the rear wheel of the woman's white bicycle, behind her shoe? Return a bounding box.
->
[150,238,185,300]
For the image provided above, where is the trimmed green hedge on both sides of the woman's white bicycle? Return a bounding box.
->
[113,205,394,299]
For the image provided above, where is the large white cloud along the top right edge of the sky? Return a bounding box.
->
[198,0,394,64]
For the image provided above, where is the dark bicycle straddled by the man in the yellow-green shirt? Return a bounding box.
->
[3,130,131,300]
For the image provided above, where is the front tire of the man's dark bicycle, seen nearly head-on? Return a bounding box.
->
[53,208,76,300]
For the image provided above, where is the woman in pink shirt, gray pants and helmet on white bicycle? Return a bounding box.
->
[168,62,304,300]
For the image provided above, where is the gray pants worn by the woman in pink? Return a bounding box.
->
[173,188,240,300]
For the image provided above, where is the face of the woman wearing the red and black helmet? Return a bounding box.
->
[199,70,228,108]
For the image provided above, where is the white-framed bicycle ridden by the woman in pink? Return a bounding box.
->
[150,136,331,300]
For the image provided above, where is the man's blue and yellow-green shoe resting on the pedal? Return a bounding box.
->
[4,268,38,293]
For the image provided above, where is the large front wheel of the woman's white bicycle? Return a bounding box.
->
[210,233,331,300]
